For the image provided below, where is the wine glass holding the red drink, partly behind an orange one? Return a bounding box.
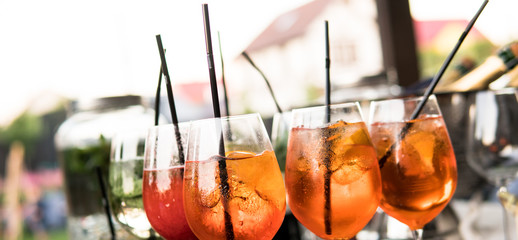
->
[142,123,196,239]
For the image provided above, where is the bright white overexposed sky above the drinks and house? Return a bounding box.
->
[0,0,518,126]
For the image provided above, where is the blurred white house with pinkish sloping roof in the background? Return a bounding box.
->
[229,0,383,114]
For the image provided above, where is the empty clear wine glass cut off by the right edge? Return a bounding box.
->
[466,89,518,239]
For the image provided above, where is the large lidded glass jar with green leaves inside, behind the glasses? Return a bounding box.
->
[55,95,154,240]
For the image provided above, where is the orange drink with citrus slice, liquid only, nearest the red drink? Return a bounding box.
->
[184,151,286,239]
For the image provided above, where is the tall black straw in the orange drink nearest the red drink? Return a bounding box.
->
[202,3,234,240]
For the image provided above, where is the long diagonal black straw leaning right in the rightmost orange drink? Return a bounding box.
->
[379,0,489,168]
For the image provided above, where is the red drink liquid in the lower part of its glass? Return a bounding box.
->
[142,166,196,239]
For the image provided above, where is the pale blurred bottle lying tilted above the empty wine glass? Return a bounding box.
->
[436,41,518,92]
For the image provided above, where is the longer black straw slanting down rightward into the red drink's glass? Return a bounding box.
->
[156,34,185,164]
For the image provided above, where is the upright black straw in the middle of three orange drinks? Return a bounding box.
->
[323,20,332,235]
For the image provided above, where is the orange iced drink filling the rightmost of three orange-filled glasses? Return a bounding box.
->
[371,116,457,230]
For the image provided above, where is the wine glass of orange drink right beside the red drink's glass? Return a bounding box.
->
[184,113,286,239]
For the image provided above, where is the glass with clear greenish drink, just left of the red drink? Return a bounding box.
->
[108,129,156,239]
